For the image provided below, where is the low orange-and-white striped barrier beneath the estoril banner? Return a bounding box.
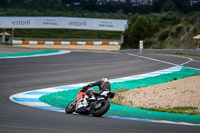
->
[12,40,121,45]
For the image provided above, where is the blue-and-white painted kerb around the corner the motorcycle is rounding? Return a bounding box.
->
[10,66,200,126]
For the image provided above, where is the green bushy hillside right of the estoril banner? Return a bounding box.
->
[121,0,200,49]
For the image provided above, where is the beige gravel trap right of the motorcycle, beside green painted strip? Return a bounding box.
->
[116,75,200,112]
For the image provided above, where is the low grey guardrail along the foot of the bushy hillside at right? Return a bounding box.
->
[120,49,200,56]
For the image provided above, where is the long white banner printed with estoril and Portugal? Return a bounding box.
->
[0,17,127,31]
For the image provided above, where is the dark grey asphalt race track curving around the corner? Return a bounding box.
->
[0,49,200,133]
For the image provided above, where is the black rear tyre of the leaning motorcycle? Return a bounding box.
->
[91,100,110,117]
